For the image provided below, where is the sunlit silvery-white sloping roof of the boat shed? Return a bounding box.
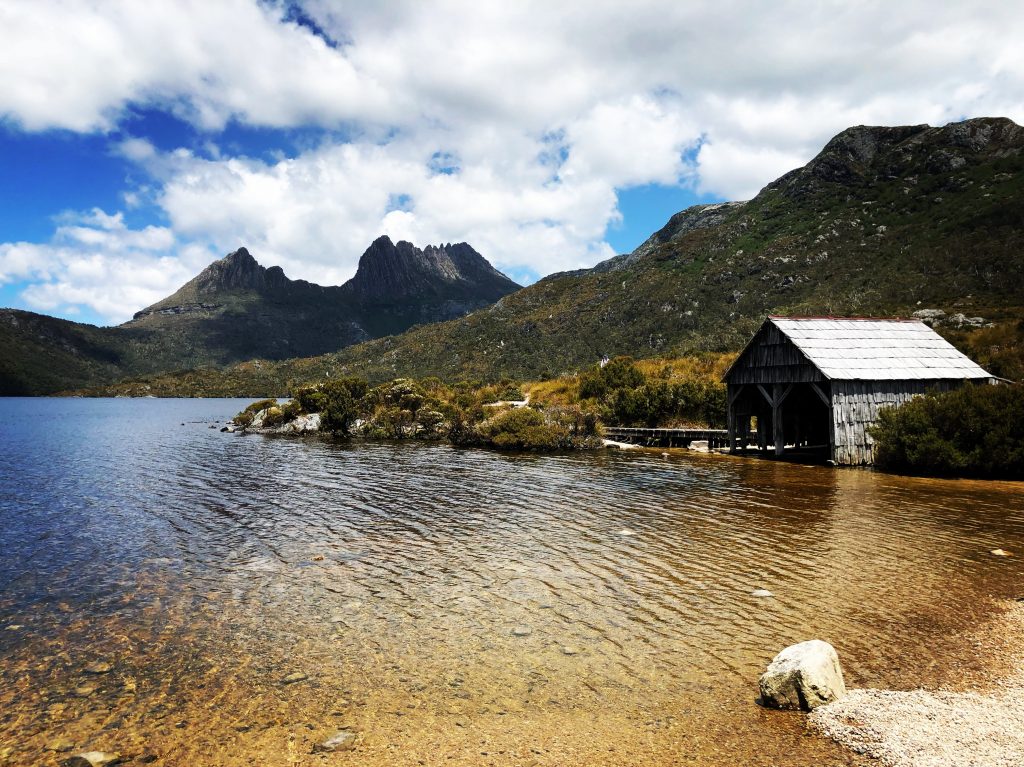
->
[768,316,991,381]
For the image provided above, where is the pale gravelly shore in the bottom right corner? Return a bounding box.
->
[809,602,1024,767]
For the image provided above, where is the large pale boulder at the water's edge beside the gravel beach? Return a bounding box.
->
[759,639,846,711]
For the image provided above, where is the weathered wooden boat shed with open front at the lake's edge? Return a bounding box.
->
[724,316,996,465]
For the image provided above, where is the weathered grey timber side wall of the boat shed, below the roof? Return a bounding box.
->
[833,381,963,466]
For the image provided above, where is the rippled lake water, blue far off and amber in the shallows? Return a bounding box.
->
[0,399,1024,766]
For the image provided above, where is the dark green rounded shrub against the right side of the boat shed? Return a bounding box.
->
[870,385,1024,479]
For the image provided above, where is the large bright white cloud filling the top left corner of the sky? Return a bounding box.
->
[0,0,394,131]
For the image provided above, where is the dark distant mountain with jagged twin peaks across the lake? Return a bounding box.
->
[0,237,519,394]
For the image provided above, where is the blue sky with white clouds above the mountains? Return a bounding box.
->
[0,0,1024,325]
